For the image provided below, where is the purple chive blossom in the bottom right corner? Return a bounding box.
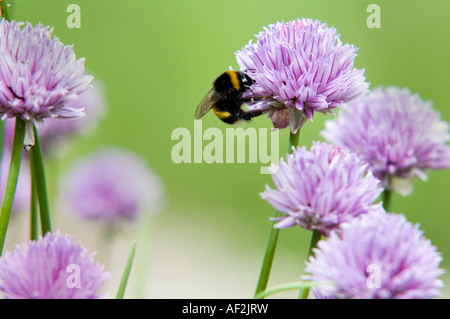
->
[303,211,443,299]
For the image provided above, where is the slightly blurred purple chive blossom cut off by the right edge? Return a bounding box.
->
[322,87,450,195]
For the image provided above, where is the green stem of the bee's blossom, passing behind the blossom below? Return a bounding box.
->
[255,130,300,297]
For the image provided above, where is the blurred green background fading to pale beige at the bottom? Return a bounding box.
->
[7,0,450,298]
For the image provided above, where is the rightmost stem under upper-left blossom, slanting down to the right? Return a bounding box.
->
[30,125,52,236]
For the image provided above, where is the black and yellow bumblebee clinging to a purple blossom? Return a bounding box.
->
[195,70,264,124]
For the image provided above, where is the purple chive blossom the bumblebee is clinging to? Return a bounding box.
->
[236,19,369,133]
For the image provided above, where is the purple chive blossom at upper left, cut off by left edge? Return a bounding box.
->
[0,19,92,121]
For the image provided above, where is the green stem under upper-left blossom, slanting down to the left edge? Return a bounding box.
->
[0,118,25,255]
